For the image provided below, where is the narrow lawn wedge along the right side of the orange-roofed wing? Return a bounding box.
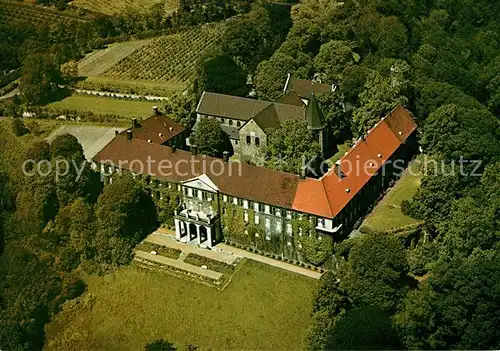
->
[362,157,422,231]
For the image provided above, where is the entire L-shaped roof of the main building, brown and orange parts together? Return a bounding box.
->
[94,106,416,218]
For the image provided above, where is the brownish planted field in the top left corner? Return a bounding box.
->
[0,0,89,27]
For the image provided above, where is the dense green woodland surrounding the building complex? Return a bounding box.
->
[0,0,500,350]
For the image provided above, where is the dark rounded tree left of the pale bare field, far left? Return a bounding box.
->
[19,54,61,105]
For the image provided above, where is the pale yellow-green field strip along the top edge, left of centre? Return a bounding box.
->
[70,0,179,15]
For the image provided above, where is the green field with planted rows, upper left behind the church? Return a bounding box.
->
[102,23,225,89]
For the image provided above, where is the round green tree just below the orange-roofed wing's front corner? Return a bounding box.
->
[339,232,408,311]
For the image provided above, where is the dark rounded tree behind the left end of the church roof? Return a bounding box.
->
[194,55,250,96]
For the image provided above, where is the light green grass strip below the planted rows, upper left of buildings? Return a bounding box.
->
[48,95,158,118]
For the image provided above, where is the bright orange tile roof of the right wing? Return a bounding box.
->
[292,106,416,218]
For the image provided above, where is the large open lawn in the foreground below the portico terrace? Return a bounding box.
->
[46,261,317,350]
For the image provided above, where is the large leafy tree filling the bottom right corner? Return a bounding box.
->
[395,250,500,349]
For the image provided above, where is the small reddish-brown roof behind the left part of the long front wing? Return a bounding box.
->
[121,115,186,144]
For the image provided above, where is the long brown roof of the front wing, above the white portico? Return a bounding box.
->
[93,135,300,208]
